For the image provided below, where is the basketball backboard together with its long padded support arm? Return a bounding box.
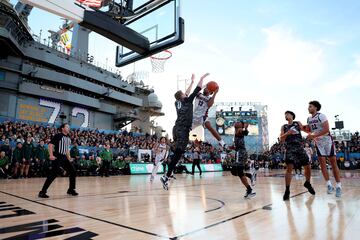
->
[21,0,184,67]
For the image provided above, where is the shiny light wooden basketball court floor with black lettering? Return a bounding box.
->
[0,171,360,240]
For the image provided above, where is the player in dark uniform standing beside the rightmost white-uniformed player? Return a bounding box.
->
[280,111,315,201]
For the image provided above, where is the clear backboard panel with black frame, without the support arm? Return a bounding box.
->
[116,0,184,67]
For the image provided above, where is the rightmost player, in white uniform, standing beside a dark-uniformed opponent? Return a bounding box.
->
[304,101,342,197]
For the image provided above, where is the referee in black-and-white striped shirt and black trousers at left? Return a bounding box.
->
[38,123,79,198]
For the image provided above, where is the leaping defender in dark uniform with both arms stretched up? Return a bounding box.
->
[160,73,209,190]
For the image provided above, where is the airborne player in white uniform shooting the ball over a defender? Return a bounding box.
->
[186,75,225,147]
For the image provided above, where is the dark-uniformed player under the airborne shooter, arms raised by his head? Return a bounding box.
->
[231,122,256,198]
